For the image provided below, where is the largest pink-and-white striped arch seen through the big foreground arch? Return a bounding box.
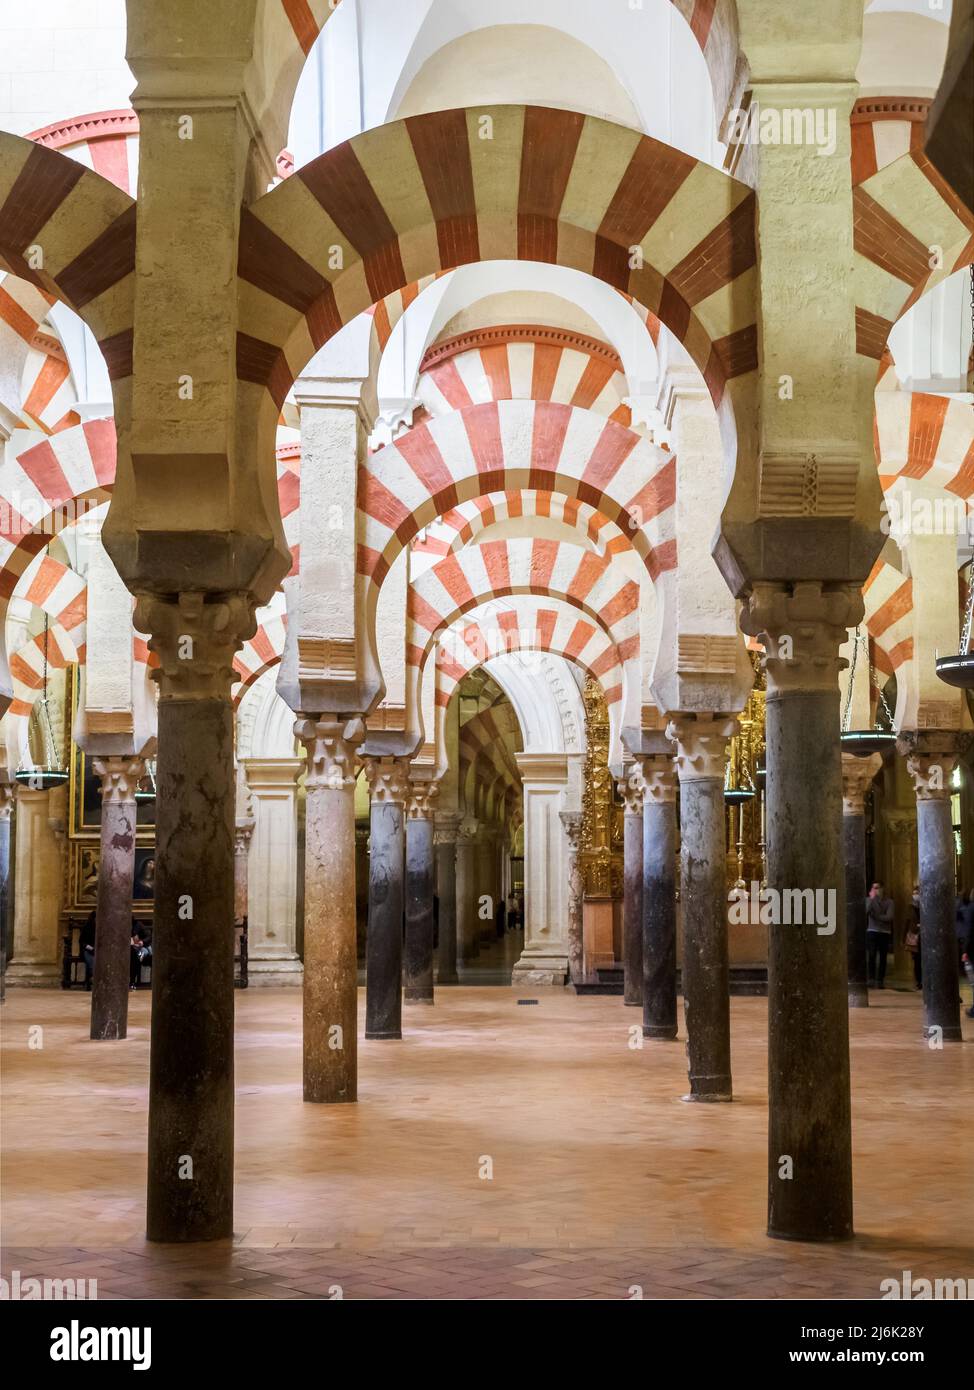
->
[358,400,677,610]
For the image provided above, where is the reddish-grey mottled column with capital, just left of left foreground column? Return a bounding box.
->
[90,758,146,1043]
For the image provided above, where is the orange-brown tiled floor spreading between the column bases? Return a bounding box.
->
[0,987,974,1300]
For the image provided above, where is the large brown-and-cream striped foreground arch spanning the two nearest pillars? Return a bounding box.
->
[238,106,757,467]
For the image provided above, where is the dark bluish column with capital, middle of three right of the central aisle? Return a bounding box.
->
[642,756,677,1041]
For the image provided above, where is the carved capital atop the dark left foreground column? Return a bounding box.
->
[135,592,257,701]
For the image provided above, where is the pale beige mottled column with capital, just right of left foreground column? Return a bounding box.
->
[295,714,365,1105]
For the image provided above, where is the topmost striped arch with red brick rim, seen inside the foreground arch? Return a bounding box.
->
[417,324,632,427]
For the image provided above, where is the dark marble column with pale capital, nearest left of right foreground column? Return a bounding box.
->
[667,714,738,1101]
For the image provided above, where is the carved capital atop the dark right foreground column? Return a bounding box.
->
[741,581,864,699]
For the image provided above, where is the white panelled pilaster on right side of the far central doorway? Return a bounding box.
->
[511,753,568,986]
